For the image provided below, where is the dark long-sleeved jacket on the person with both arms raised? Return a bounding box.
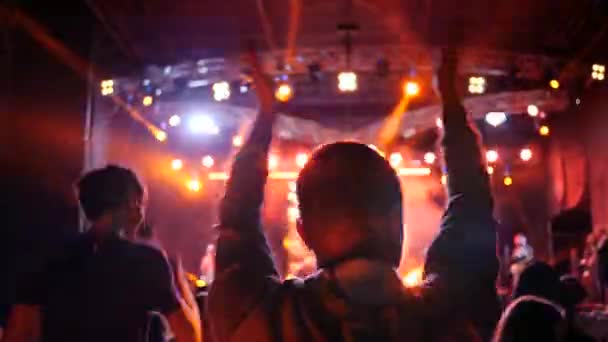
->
[208,103,500,341]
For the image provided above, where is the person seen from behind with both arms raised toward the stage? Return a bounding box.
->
[208,48,500,341]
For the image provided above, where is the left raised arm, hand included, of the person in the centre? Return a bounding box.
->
[208,49,278,341]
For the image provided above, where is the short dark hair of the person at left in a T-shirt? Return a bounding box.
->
[75,165,144,220]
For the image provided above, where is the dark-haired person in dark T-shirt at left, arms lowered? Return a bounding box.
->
[5,166,201,342]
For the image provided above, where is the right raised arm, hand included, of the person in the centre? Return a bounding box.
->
[425,49,500,338]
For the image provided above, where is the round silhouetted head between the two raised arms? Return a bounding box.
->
[297,142,403,267]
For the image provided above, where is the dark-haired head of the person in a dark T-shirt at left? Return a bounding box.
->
[76,165,145,234]
